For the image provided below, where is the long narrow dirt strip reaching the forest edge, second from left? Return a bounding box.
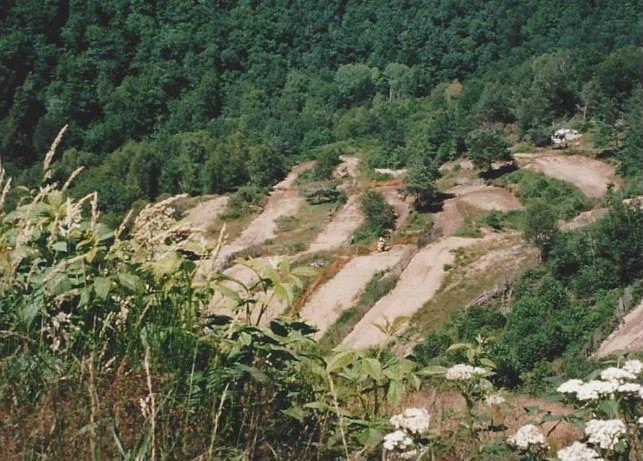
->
[213,162,312,267]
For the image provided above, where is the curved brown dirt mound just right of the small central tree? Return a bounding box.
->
[433,185,523,236]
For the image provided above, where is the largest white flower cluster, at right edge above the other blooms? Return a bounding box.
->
[558,360,643,401]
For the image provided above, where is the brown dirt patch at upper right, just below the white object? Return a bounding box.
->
[517,154,621,198]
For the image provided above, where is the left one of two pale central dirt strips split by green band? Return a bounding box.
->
[300,246,407,338]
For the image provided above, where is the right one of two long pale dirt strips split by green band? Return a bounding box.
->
[342,237,488,349]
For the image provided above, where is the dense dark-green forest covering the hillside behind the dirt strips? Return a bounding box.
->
[0,0,642,222]
